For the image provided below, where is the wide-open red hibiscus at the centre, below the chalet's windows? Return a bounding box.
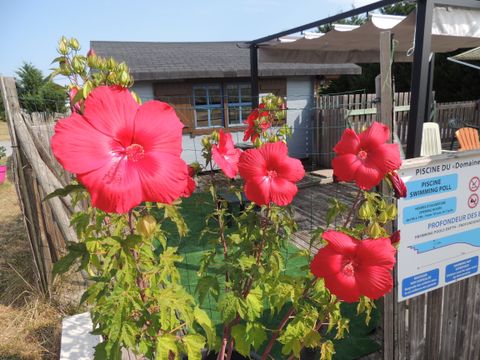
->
[238,141,305,206]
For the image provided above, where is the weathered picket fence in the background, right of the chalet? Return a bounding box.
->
[313,92,480,167]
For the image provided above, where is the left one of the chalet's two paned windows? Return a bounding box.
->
[193,85,224,129]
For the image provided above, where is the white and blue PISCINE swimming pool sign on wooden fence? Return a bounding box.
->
[397,150,480,301]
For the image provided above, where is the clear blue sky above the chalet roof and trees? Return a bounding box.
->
[0,0,375,76]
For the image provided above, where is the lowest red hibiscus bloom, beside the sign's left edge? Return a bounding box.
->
[310,230,395,302]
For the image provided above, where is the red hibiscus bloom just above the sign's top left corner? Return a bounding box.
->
[332,122,402,190]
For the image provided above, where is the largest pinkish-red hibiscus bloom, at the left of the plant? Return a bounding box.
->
[52,86,188,213]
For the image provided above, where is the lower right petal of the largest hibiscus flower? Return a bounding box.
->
[137,151,189,204]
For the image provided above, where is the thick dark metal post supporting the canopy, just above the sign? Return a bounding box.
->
[406,0,433,158]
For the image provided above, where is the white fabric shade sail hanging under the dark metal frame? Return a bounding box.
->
[259,7,480,64]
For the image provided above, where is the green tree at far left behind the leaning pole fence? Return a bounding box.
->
[16,63,67,112]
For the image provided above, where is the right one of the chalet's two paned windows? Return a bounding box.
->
[226,84,252,126]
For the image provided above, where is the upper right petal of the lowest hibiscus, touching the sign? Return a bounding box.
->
[357,238,396,270]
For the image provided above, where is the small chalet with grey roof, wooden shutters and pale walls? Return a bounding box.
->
[91,41,361,162]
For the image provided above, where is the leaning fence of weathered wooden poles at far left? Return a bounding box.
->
[0,77,77,293]
